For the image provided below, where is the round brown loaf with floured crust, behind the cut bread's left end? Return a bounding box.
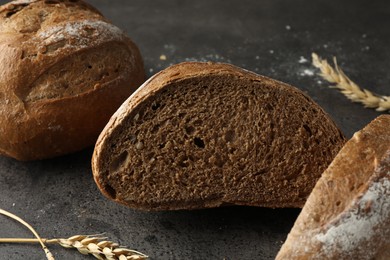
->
[0,0,145,160]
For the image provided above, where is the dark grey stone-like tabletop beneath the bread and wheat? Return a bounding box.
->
[0,0,390,260]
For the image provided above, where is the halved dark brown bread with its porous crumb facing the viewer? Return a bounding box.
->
[92,62,344,210]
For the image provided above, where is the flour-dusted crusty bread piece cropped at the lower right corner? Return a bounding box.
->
[276,115,390,259]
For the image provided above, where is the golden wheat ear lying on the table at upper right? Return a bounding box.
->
[312,53,390,111]
